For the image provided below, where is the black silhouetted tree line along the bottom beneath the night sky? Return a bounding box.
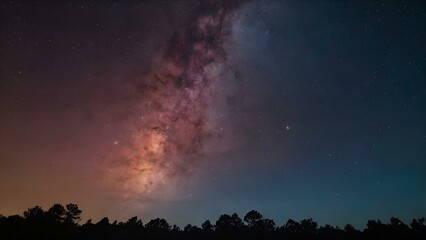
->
[0,203,426,240]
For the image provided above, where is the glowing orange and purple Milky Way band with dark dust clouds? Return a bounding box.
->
[102,1,241,201]
